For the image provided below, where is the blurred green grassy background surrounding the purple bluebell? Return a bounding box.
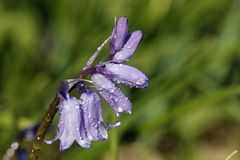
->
[0,0,240,160]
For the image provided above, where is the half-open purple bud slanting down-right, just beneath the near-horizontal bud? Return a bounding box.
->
[92,73,132,116]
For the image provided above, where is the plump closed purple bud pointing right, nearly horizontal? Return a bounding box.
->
[97,63,148,88]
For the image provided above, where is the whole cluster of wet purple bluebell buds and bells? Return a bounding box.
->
[46,17,148,150]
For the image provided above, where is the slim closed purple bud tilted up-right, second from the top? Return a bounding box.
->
[112,31,142,63]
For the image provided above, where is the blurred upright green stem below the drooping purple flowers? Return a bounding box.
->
[110,117,119,160]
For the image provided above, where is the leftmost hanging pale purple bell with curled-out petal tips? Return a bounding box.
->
[46,96,91,150]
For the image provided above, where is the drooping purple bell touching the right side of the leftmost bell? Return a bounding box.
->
[81,91,108,141]
